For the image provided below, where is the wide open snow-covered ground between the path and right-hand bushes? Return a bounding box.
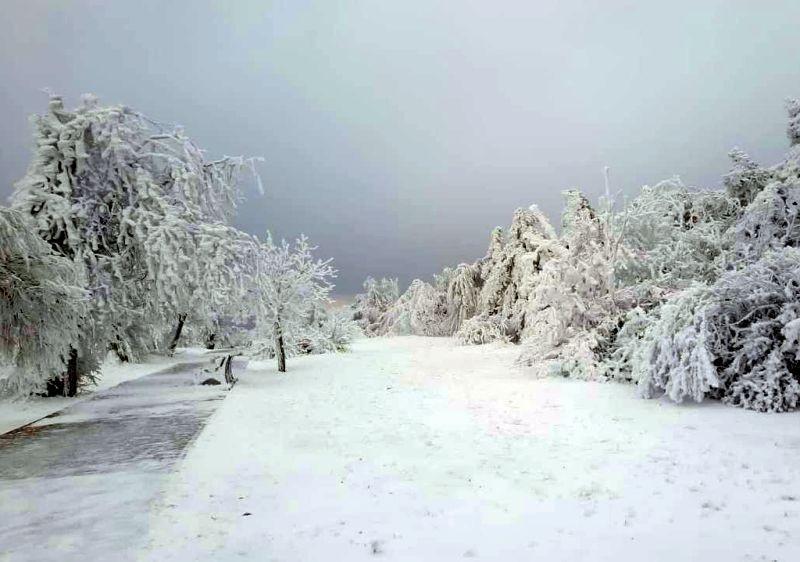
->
[140,338,800,562]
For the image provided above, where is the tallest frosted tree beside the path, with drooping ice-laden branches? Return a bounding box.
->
[12,96,260,368]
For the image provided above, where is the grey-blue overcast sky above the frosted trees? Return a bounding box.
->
[0,0,800,294]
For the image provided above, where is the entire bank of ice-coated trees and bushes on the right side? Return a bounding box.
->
[334,95,800,412]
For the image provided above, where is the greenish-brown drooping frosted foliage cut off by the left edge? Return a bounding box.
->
[0,208,87,397]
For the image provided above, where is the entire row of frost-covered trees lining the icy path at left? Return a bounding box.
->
[0,96,352,396]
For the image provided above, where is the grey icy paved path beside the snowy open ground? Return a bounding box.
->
[0,360,241,561]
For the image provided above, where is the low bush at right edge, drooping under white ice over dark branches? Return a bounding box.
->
[632,248,800,412]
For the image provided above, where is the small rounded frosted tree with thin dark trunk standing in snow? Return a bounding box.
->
[251,236,336,373]
